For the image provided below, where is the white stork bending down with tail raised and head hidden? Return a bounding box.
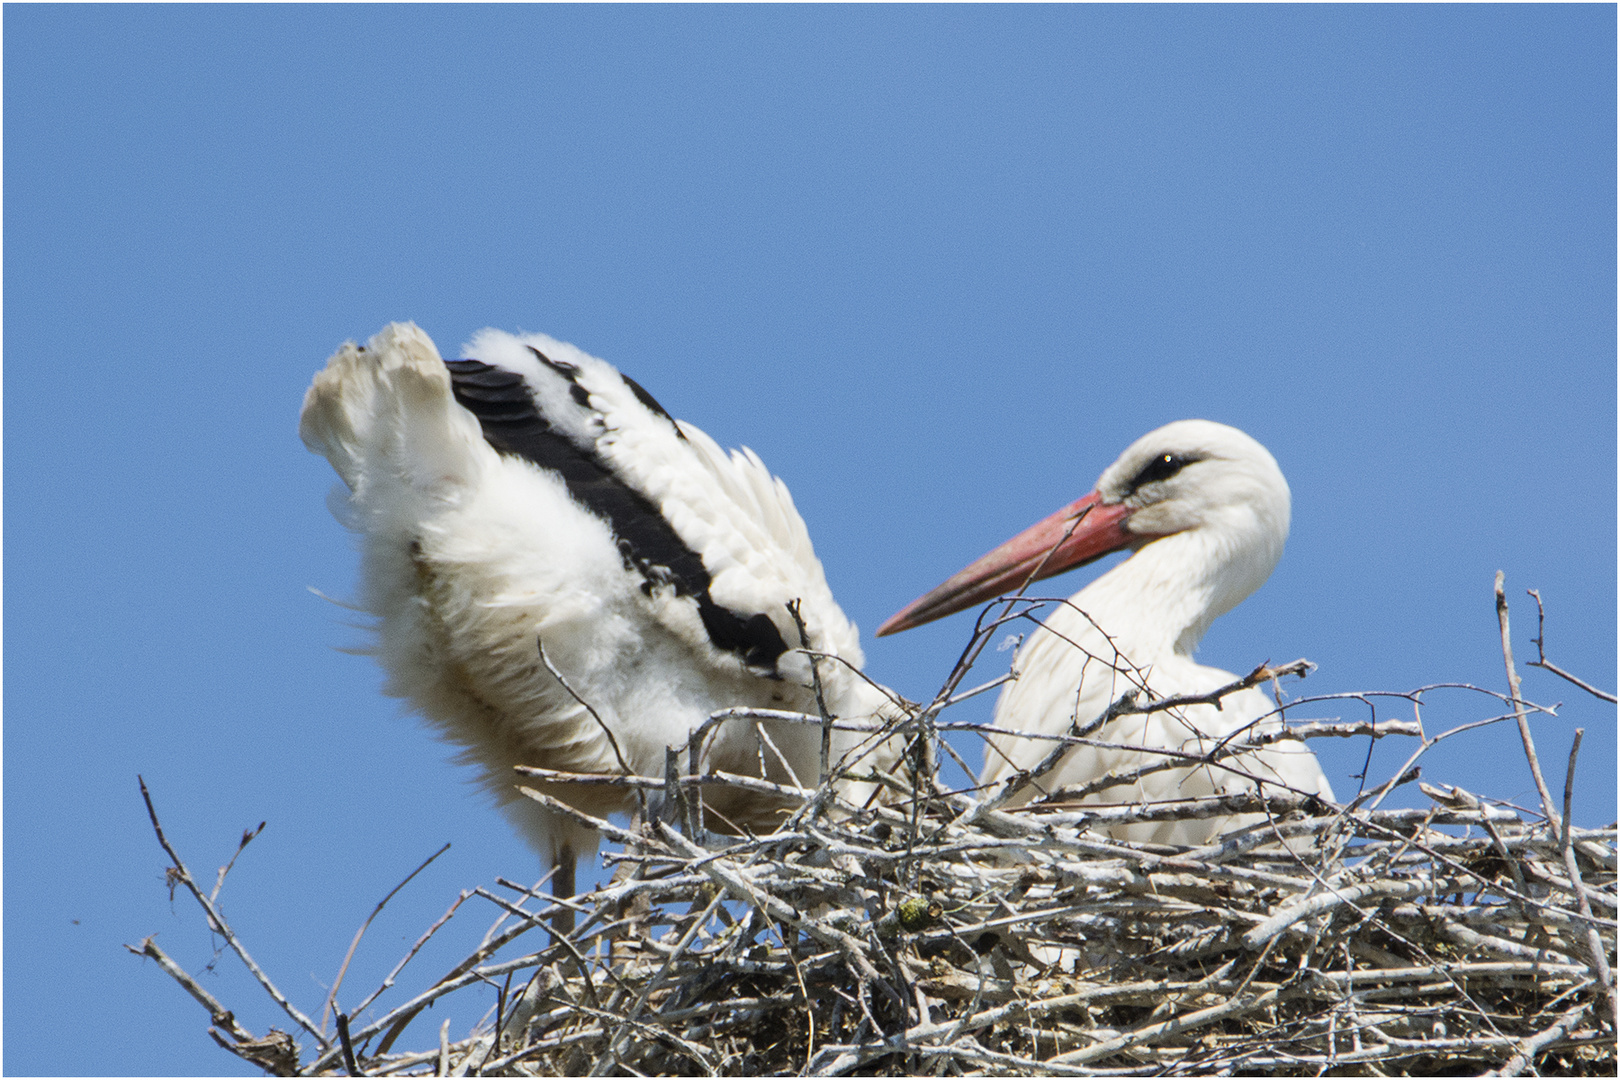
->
[300,324,896,895]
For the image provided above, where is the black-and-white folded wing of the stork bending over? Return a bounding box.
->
[447,330,862,674]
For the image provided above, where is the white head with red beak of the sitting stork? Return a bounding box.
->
[878,419,1290,636]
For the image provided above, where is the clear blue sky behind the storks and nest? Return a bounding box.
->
[3,5,1617,1075]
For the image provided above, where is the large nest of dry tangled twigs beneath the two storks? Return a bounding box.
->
[136,586,1617,1075]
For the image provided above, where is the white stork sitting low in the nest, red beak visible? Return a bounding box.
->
[878,419,1333,845]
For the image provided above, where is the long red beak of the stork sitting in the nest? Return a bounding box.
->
[878,491,1149,638]
